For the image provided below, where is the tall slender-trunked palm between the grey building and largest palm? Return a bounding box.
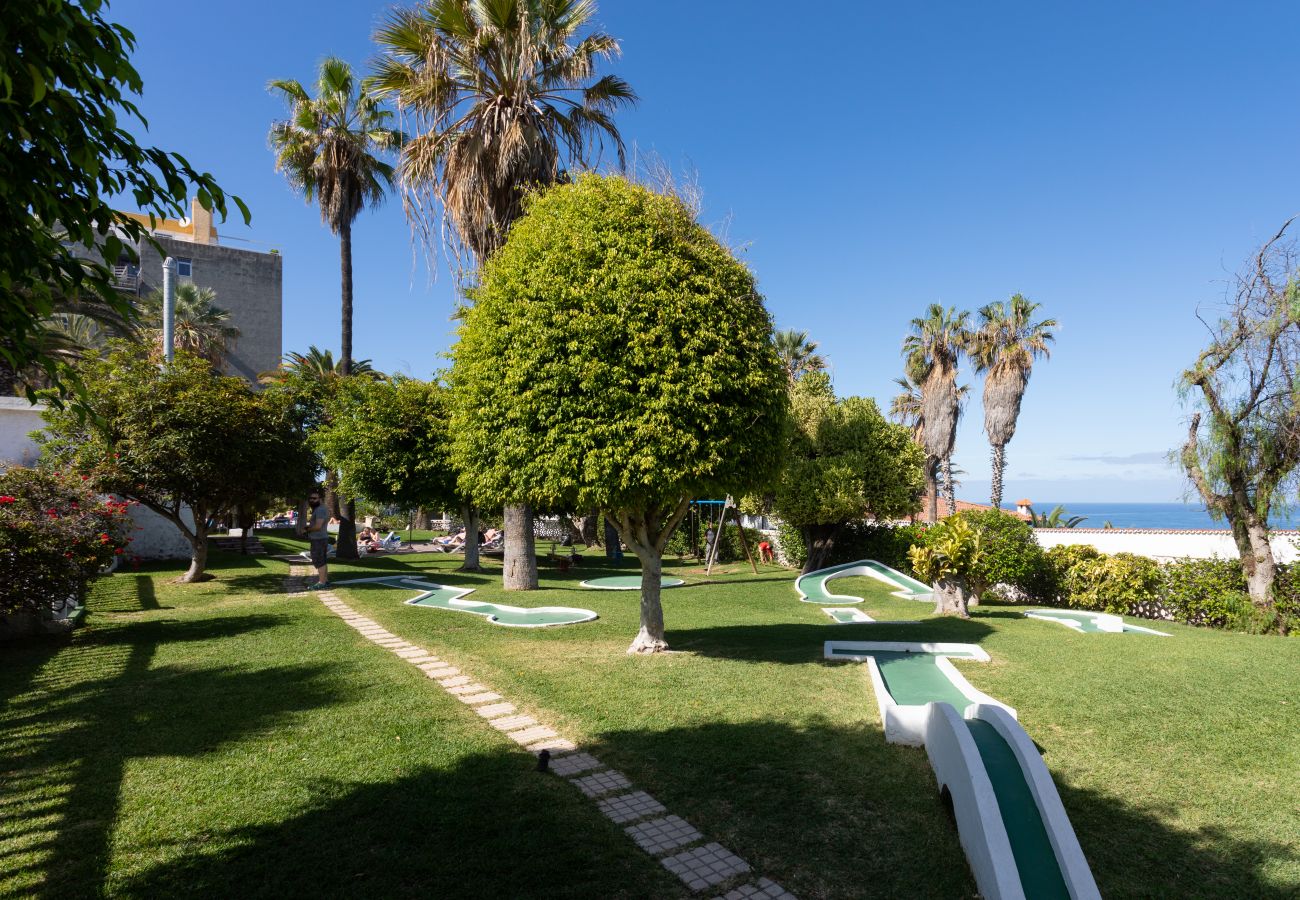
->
[269,57,403,558]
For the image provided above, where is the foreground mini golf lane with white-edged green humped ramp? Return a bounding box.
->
[824,641,1101,900]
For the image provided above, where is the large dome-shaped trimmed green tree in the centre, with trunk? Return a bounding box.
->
[451,174,788,653]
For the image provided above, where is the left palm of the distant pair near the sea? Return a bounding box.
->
[902,303,970,522]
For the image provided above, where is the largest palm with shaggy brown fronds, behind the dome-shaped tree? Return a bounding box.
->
[367,0,636,590]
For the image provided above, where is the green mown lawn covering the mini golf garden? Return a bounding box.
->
[0,538,1300,897]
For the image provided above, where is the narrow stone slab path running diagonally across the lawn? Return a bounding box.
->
[285,564,794,900]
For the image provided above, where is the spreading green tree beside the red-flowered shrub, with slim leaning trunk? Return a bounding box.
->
[39,345,316,581]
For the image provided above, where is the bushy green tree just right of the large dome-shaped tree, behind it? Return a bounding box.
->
[774,372,926,571]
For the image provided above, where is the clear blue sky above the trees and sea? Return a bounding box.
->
[109,0,1300,506]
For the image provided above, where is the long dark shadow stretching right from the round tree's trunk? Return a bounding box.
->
[667,616,993,665]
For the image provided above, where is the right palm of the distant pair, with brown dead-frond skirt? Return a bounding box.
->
[970,294,1057,509]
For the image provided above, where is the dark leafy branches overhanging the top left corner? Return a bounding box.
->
[0,0,248,398]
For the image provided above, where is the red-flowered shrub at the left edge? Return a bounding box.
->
[0,468,130,615]
